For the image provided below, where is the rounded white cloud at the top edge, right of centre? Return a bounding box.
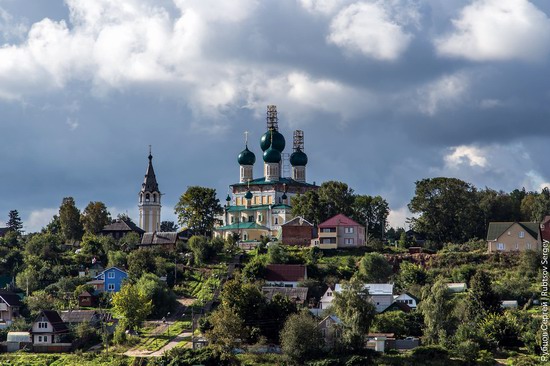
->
[327,2,413,60]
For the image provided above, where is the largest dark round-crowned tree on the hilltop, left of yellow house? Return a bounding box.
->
[408,177,485,244]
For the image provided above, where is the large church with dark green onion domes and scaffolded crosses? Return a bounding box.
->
[214,105,319,241]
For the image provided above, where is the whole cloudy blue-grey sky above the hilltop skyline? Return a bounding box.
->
[0,0,550,232]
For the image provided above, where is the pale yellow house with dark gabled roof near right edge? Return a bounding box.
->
[487,222,542,253]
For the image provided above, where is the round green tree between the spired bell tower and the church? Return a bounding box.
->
[175,186,222,236]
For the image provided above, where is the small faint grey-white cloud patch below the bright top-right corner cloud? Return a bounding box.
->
[418,73,470,116]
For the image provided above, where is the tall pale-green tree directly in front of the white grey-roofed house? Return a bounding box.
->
[331,281,376,351]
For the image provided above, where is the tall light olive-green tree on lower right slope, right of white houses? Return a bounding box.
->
[418,278,456,344]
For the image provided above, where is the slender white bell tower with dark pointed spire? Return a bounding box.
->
[138,145,161,232]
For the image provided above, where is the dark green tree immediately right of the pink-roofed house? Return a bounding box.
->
[352,195,390,239]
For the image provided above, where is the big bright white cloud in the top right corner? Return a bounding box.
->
[435,0,550,61]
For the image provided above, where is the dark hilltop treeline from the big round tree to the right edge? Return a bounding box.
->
[408,177,550,244]
